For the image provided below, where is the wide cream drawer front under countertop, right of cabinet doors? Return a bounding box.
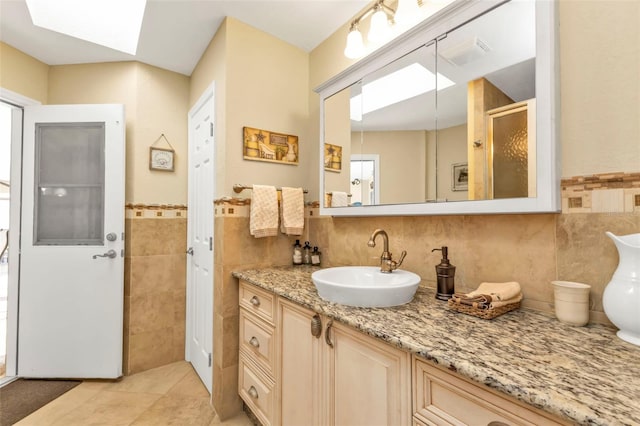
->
[413,359,561,425]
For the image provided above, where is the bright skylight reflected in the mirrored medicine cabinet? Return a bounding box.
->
[350,63,455,121]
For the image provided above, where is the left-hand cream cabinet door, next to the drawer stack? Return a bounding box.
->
[278,299,326,426]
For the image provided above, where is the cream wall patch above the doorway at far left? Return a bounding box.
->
[0,41,49,104]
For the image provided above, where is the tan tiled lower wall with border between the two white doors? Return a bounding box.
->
[123,204,187,375]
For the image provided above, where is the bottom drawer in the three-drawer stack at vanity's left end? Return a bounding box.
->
[238,353,275,426]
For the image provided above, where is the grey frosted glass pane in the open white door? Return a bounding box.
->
[34,123,105,245]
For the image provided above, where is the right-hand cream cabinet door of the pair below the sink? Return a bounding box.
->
[325,323,411,426]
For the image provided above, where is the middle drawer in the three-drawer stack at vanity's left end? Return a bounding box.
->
[240,308,275,376]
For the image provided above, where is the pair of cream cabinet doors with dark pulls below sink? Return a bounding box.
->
[278,299,411,425]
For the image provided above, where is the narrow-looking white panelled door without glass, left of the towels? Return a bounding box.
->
[185,81,215,393]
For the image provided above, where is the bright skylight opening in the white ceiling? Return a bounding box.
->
[26,0,146,55]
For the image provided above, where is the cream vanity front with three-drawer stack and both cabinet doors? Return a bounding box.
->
[238,281,411,426]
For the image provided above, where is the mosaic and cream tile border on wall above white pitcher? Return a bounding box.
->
[561,172,640,213]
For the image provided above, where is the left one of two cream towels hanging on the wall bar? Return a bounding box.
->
[249,185,278,238]
